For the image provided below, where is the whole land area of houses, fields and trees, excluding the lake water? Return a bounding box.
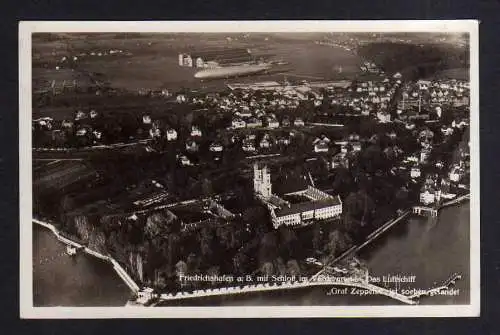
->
[32,33,470,305]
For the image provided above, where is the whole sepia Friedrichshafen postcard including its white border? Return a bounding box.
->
[19,20,480,318]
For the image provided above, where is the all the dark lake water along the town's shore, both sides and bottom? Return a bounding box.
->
[33,202,468,306]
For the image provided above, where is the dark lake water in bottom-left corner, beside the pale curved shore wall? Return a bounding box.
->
[33,224,131,306]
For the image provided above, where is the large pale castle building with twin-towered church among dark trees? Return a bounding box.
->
[254,164,342,229]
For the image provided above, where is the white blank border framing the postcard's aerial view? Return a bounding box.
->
[19,20,480,319]
